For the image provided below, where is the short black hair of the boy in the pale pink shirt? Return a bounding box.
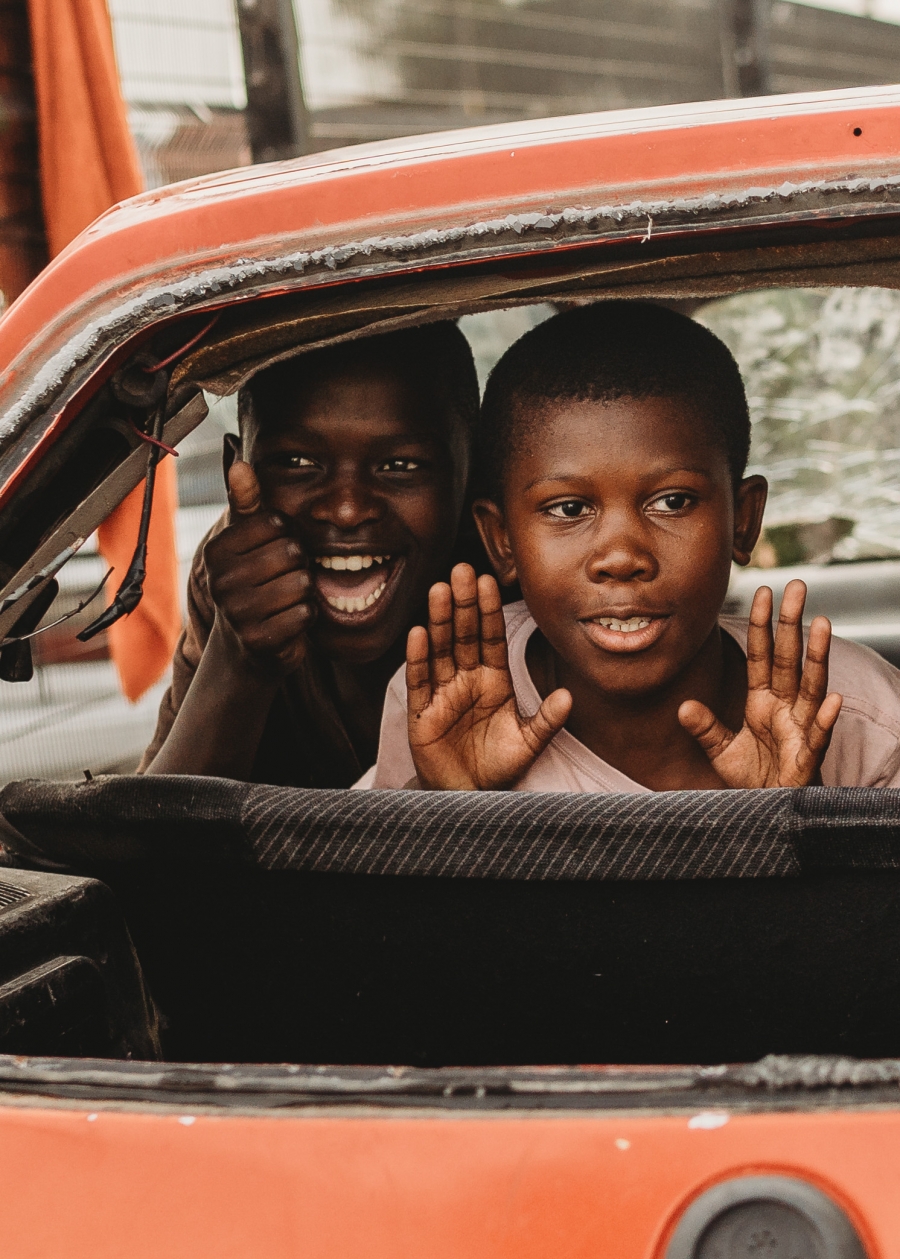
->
[478,301,750,501]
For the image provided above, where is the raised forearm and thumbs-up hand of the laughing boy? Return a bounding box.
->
[145,462,313,779]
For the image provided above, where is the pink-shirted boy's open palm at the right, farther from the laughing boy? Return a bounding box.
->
[678,580,841,787]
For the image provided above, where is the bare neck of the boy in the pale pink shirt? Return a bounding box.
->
[526,626,746,791]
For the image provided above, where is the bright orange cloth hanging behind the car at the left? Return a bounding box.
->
[29,0,181,700]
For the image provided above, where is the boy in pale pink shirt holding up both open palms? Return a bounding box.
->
[360,301,900,792]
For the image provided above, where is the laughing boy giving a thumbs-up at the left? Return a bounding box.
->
[142,324,478,787]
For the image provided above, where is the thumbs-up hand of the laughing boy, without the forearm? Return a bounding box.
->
[204,460,315,677]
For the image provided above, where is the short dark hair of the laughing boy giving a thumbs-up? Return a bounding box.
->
[238,320,478,437]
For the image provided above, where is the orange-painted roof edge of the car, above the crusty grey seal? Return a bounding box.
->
[0,87,900,420]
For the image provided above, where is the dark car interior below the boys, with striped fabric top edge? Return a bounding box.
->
[0,777,900,1068]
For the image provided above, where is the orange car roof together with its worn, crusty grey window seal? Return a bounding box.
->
[0,87,900,541]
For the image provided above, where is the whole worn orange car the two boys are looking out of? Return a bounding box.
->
[0,87,900,1259]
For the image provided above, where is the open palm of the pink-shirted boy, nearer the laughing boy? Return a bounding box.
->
[407,564,571,791]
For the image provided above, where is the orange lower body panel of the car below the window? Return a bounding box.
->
[0,1103,900,1259]
